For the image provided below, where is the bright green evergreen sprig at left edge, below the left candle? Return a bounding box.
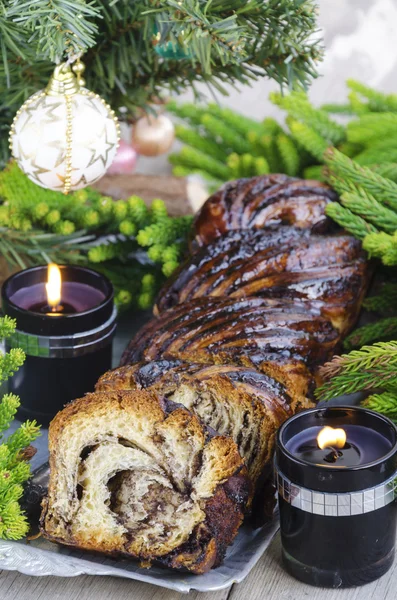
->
[0,317,40,540]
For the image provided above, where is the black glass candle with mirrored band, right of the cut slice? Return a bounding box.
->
[275,406,397,588]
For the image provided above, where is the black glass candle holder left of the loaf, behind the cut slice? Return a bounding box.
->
[2,265,116,425]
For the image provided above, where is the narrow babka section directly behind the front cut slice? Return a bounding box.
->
[96,360,311,485]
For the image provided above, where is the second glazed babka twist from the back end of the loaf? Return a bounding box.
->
[155,227,367,333]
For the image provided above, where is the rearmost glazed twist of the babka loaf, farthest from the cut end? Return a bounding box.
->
[191,174,337,251]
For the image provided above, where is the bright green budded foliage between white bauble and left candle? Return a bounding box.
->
[0,163,192,309]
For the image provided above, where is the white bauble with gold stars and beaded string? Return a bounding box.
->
[10,64,120,194]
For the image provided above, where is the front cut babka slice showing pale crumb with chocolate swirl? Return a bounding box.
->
[41,390,252,573]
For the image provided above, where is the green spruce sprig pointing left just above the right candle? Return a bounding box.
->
[316,342,397,400]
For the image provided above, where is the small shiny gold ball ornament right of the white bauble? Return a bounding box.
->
[132,115,175,156]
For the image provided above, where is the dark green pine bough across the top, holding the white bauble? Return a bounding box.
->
[0,0,322,161]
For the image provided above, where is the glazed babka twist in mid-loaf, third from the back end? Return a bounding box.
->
[121,298,339,396]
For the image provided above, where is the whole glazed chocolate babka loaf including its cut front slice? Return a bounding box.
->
[42,175,368,573]
